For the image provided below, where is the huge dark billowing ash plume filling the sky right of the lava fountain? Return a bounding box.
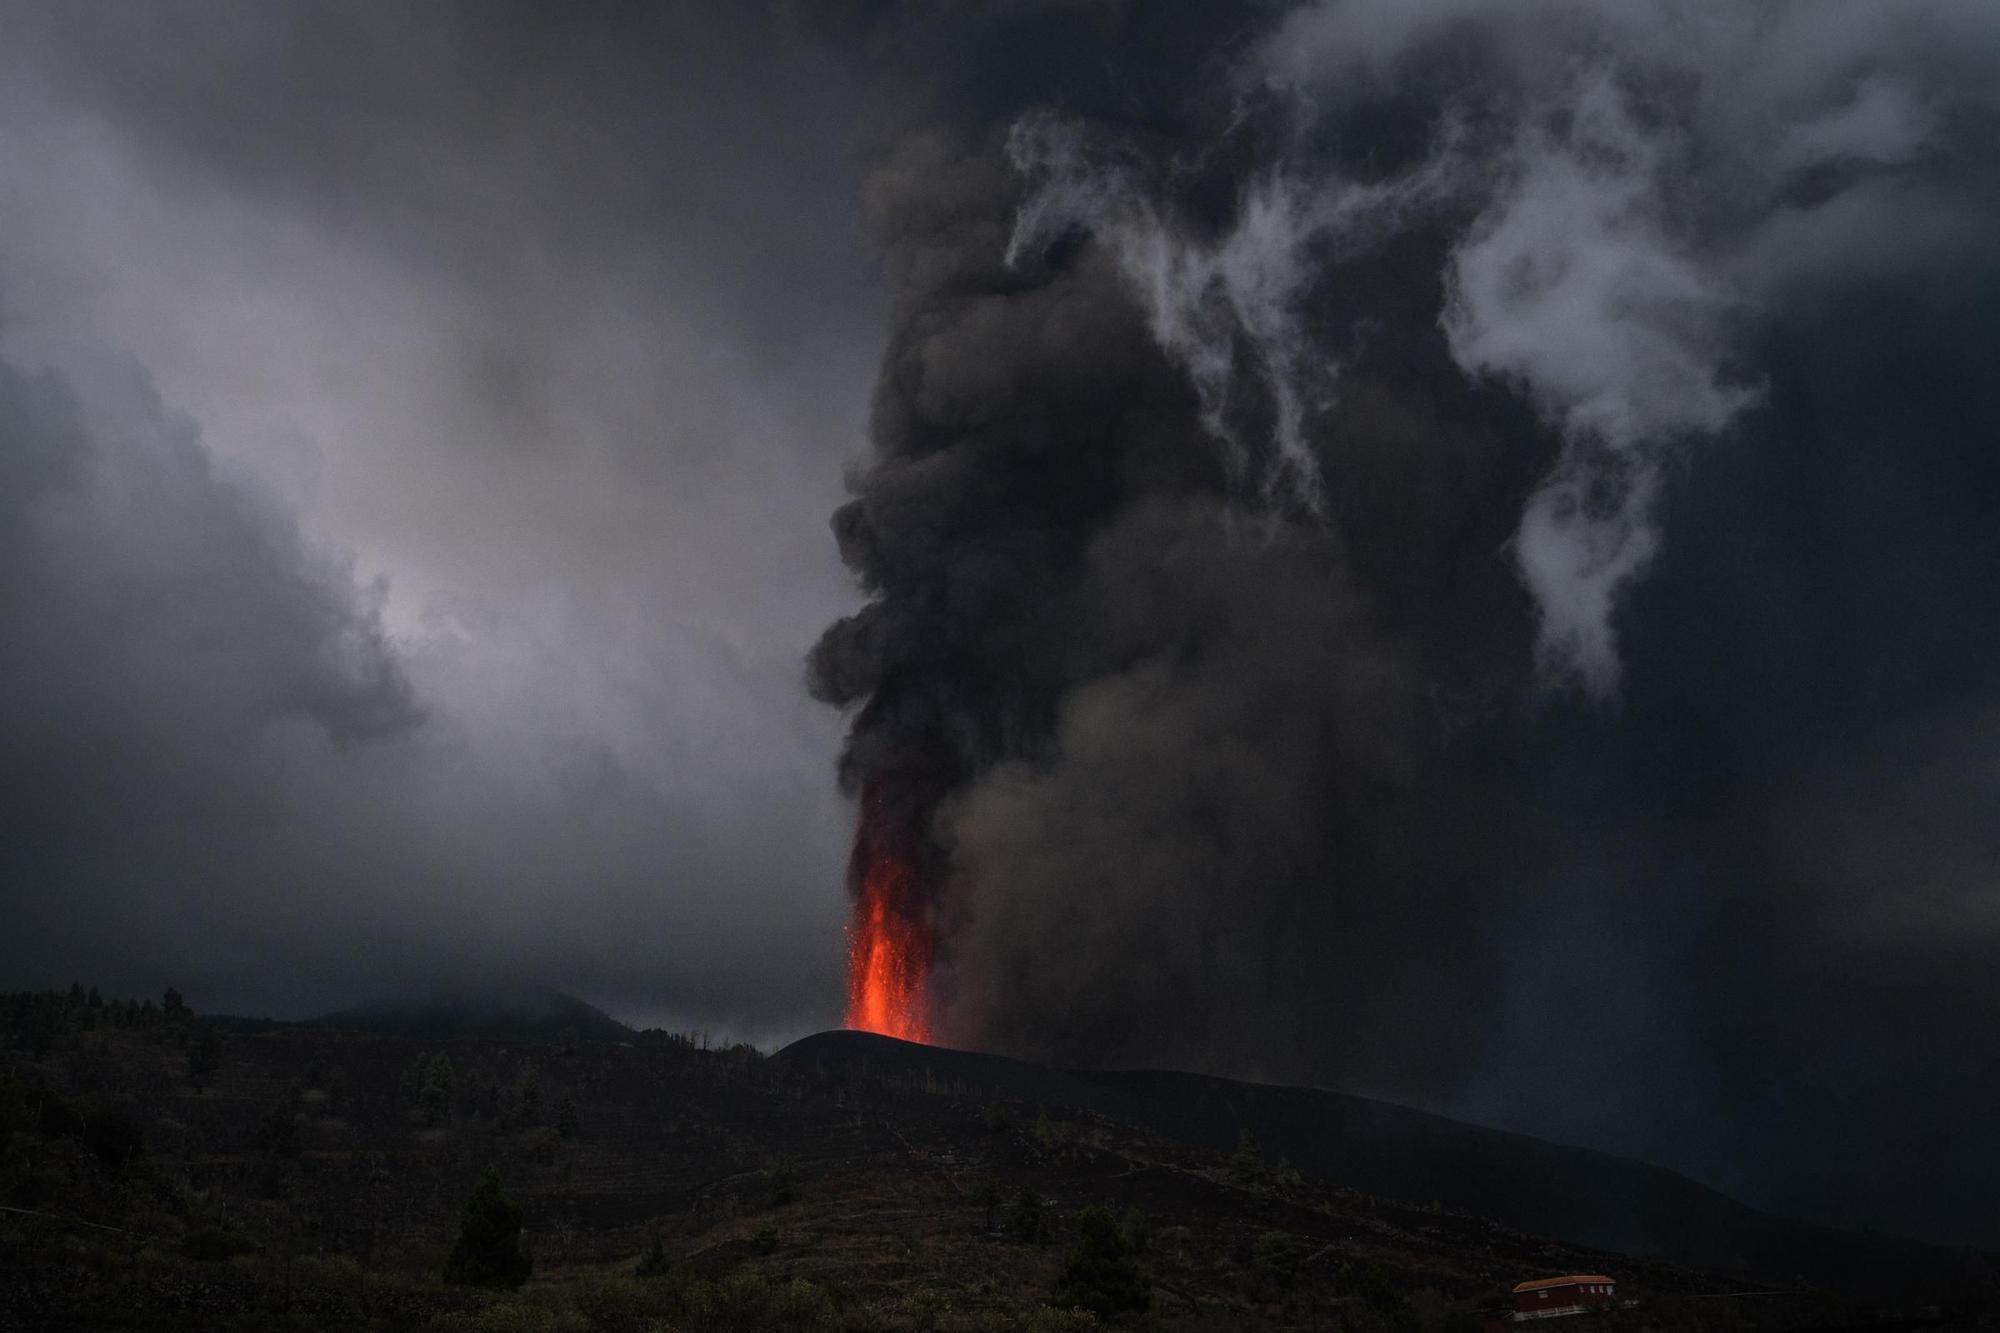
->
[810,0,2000,1248]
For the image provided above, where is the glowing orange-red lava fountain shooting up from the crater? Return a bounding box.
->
[848,779,930,1041]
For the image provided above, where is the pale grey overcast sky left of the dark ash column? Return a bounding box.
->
[0,4,880,1037]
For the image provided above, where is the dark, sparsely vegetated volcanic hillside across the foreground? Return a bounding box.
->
[0,997,1994,1333]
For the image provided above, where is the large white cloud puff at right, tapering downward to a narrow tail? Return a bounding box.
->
[1444,76,1752,699]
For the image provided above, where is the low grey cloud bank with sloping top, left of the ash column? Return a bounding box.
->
[0,338,840,1020]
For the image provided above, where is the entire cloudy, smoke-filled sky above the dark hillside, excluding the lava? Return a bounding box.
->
[0,0,2000,1245]
